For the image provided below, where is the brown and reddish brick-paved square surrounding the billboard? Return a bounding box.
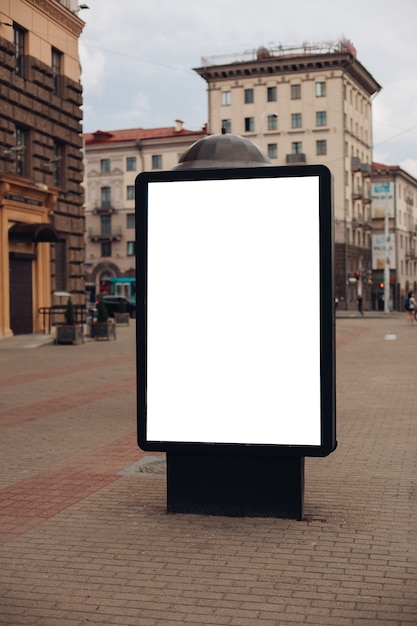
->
[0,315,417,626]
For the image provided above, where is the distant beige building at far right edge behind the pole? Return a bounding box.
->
[370,163,417,310]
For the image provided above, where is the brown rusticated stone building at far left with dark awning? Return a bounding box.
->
[0,0,85,338]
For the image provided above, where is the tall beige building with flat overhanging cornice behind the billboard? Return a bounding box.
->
[195,41,380,308]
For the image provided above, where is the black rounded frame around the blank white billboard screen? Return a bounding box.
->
[135,165,337,457]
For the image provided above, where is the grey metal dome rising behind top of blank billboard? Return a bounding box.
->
[172,134,272,170]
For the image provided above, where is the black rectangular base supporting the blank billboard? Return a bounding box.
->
[166,452,304,520]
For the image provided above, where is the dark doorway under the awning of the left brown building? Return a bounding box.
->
[9,253,33,335]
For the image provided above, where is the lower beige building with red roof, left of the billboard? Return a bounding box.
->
[84,120,206,293]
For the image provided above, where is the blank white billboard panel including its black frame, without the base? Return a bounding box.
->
[136,166,336,456]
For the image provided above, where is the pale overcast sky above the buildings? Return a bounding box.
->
[79,0,417,178]
